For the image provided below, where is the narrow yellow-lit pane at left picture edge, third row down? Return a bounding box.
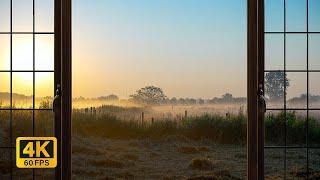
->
[0,73,10,109]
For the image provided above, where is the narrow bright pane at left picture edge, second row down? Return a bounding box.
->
[0,34,10,70]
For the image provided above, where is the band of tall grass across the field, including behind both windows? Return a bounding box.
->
[0,107,320,145]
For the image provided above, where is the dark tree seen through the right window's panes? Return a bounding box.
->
[265,72,289,101]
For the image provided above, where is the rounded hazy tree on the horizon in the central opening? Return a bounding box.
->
[130,86,166,104]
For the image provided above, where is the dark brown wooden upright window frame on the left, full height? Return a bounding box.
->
[54,0,72,180]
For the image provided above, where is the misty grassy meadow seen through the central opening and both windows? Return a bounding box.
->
[0,103,320,179]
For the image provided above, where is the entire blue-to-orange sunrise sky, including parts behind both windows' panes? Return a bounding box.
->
[0,0,320,98]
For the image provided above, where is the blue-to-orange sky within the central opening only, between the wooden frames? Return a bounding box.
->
[73,0,246,98]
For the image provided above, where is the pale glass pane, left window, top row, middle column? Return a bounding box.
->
[12,0,33,32]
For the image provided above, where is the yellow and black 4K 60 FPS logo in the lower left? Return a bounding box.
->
[16,137,57,168]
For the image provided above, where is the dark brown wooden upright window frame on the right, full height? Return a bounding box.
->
[247,0,265,180]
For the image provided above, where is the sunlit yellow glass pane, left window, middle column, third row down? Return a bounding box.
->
[12,72,33,108]
